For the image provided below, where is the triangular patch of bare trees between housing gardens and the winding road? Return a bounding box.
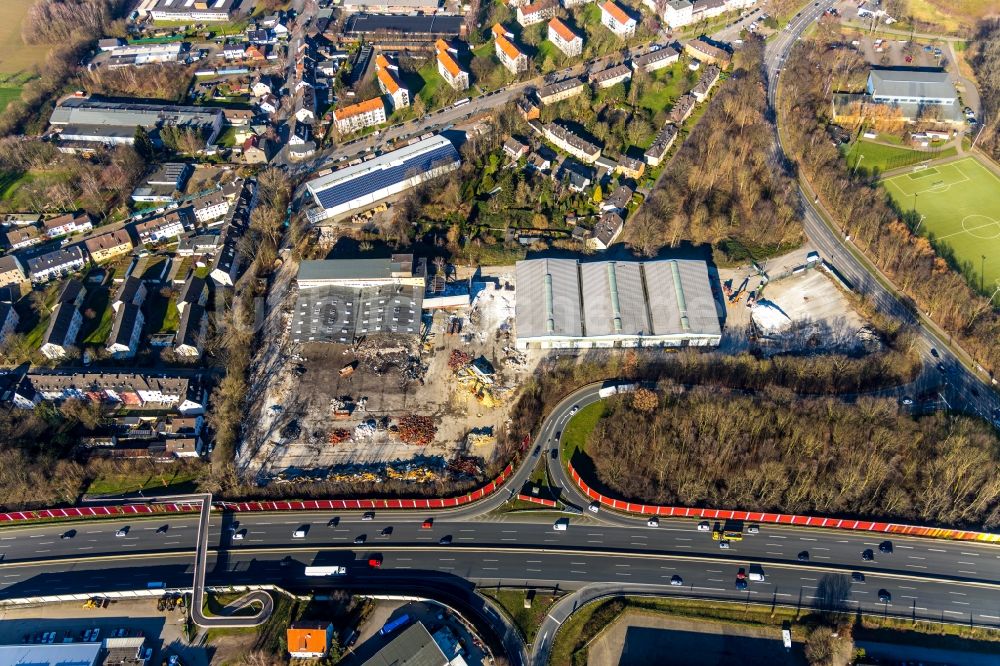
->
[625,38,802,259]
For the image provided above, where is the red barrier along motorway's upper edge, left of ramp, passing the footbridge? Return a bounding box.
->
[0,463,514,524]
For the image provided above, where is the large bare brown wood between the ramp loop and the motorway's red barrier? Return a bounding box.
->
[587,383,1000,529]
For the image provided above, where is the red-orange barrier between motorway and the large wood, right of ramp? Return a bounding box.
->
[568,464,1000,543]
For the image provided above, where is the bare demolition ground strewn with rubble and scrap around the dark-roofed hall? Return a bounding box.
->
[238,254,538,483]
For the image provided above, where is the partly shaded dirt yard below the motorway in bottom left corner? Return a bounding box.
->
[0,599,210,666]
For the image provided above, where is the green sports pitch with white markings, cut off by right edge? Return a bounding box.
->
[883,157,1000,292]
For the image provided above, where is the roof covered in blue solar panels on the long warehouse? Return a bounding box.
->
[306,135,460,209]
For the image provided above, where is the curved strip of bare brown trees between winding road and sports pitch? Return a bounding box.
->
[778,22,1000,371]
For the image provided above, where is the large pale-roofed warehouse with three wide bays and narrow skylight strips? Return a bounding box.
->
[516,259,722,349]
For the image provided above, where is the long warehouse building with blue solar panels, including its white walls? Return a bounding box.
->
[306,135,462,223]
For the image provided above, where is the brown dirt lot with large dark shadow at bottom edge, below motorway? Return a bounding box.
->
[587,612,806,666]
